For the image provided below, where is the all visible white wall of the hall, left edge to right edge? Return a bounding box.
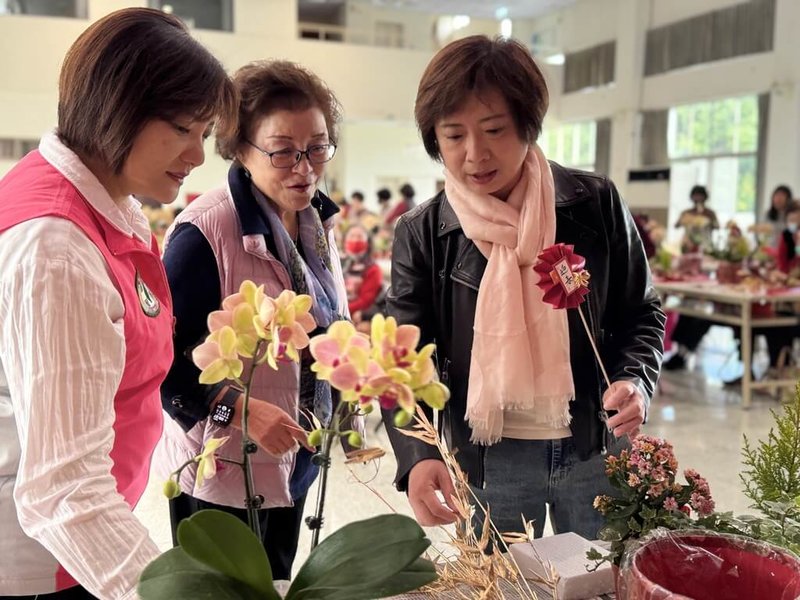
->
[0,0,800,211]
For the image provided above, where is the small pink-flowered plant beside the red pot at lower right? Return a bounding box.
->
[587,435,714,566]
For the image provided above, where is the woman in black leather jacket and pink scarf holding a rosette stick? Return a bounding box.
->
[387,36,665,538]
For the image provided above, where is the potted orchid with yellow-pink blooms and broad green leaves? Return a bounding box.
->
[138,281,449,600]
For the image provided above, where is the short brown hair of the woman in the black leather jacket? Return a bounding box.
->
[414,35,549,160]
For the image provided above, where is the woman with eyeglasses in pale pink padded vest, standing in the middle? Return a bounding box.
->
[154,61,348,579]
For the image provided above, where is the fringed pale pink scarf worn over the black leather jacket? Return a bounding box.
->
[445,146,575,445]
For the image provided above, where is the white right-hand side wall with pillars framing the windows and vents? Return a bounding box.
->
[514,0,800,214]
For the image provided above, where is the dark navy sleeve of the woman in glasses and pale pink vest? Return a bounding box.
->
[161,223,225,431]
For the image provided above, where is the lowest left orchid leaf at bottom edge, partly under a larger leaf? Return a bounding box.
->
[136,548,263,600]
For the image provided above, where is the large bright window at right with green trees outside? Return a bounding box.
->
[667,96,758,227]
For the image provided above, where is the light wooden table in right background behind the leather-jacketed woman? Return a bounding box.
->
[654,281,800,408]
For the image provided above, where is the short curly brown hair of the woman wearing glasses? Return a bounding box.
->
[217,60,342,159]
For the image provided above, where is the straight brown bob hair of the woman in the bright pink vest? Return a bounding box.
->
[58,8,237,174]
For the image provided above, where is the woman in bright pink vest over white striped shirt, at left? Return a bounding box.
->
[0,8,237,600]
